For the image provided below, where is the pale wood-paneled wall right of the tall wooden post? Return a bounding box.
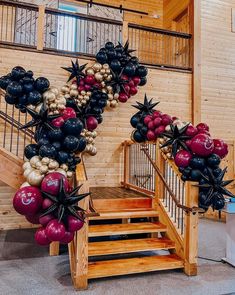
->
[201,0,235,140]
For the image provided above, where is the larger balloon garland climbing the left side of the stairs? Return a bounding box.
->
[0,42,148,245]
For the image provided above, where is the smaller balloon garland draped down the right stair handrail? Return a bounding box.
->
[130,95,234,211]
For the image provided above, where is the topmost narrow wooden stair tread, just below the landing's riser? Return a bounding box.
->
[89,209,158,220]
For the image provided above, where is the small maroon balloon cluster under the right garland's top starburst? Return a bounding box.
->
[144,111,173,141]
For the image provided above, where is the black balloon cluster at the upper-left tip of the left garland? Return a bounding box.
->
[0,66,50,112]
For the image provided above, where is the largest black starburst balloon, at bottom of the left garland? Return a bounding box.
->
[41,179,90,225]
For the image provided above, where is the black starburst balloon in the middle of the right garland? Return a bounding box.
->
[161,124,191,157]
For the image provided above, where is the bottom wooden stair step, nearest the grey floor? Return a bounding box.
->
[88,254,184,279]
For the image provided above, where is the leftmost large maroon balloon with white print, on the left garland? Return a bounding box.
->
[13,186,43,215]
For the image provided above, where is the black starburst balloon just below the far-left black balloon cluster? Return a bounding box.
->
[20,106,61,130]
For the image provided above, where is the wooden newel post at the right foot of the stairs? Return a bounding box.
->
[184,182,199,276]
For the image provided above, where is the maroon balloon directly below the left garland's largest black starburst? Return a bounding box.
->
[46,219,65,242]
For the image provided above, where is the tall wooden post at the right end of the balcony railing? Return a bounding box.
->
[190,0,201,124]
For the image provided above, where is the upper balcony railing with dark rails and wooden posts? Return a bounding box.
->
[0,0,192,70]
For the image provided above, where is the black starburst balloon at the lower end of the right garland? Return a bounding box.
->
[195,167,235,208]
